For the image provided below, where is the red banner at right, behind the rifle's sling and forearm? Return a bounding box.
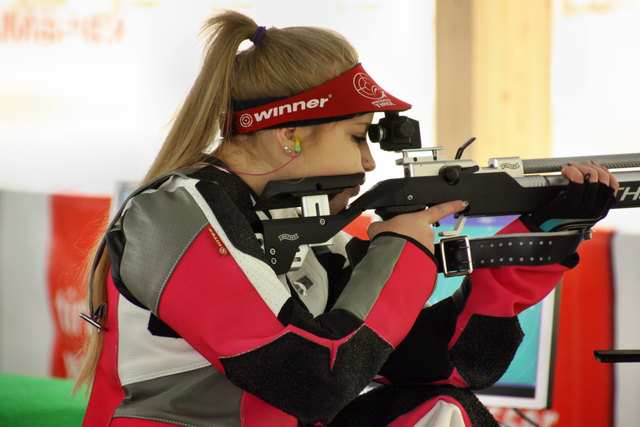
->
[553,230,614,427]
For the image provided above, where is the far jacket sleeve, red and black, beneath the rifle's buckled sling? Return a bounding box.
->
[381,219,575,389]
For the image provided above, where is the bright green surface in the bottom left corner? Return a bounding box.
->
[0,374,88,427]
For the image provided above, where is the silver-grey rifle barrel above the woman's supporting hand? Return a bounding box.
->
[522,153,640,173]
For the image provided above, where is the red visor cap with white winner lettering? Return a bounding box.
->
[233,64,411,134]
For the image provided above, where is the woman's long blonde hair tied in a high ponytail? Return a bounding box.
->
[75,11,358,390]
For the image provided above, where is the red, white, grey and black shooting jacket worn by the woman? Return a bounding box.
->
[84,165,567,426]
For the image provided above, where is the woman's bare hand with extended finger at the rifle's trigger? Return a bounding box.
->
[367,200,467,253]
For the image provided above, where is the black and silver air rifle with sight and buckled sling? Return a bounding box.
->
[256,113,640,276]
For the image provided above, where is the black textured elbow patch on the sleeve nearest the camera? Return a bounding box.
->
[221,326,393,424]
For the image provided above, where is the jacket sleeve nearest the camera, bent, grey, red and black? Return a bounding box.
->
[110,182,436,423]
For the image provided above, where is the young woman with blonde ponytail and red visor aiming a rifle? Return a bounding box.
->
[79,12,617,426]
